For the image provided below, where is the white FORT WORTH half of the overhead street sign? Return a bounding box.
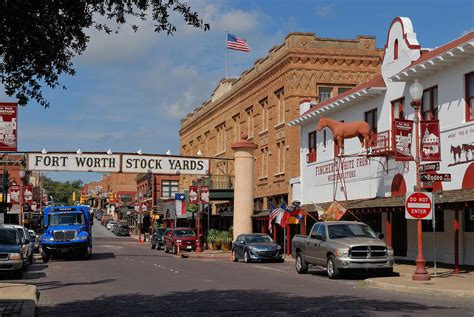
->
[28,153,120,172]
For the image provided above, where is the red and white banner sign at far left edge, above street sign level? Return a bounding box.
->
[0,102,18,152]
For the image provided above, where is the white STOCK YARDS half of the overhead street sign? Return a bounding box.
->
[122,154,209,175]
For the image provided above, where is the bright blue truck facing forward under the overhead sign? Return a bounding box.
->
[40,206,92,262]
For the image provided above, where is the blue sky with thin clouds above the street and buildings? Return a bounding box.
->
[0,0,474,182]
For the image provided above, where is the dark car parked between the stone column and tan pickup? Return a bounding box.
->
[232,233,284,263]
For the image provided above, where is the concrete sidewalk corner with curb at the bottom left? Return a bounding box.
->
[0,283,39,317]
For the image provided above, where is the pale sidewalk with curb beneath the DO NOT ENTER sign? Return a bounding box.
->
[364,264,474,299]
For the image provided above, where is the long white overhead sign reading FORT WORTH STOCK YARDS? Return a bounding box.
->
[27,153,209,175]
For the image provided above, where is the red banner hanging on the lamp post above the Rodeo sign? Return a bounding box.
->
[421,120,441,161]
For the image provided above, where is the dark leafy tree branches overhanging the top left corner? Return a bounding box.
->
[0,0,209,108]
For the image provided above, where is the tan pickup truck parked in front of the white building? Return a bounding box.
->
[291,221,394,279]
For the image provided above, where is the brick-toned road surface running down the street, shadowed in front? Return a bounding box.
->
[17,222,474,316]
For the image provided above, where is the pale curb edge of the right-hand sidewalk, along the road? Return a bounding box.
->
[363,279,474,298]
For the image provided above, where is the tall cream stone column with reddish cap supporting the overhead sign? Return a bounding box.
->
[231,133,257,240]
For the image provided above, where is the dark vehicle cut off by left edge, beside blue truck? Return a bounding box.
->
[0,226,27,278]
